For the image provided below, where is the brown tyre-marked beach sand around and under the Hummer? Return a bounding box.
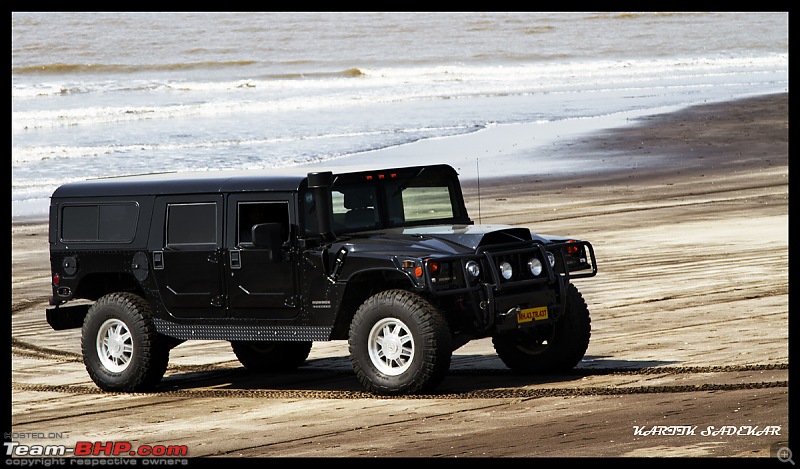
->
[11,93,789,457]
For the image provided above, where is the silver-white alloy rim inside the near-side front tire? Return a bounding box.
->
[367,318,414,376]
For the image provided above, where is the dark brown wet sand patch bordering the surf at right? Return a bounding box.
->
[468,92,789,186]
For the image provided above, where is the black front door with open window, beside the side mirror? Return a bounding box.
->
[224,193,300,320]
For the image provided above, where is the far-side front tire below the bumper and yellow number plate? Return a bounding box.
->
[492,283,592,374]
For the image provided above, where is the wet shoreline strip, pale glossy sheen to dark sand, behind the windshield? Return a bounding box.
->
[307,92,788,184]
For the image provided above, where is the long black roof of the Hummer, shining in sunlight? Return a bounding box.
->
[51,164,455,198]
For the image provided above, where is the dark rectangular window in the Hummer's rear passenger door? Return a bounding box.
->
[167,202,217,246]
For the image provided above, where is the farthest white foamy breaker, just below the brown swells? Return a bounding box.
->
[12,52,789,98]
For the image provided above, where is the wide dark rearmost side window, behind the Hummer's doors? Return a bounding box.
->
[61,202,139,243]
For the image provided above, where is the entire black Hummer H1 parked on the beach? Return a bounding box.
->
[47,165,597,395]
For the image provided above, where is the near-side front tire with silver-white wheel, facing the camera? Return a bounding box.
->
[349,290,452,396]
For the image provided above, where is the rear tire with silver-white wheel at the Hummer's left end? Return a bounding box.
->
[81,293,169,392]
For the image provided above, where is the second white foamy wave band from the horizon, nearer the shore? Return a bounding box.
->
[11,61,788,133]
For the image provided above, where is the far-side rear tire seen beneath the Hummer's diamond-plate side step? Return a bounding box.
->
[231,341,312,373]
